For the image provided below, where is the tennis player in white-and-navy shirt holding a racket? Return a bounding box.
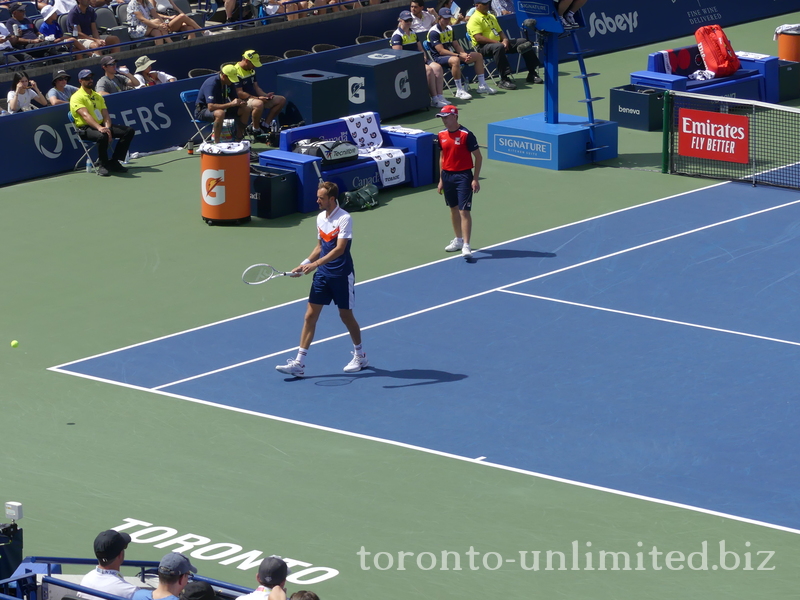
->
[275,181,369,377]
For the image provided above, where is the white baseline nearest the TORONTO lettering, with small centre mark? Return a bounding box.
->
[40,367,800,534]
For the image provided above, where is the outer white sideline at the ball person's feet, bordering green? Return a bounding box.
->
[48,181,736,373]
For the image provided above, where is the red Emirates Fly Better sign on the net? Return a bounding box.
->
[678,108,750,164]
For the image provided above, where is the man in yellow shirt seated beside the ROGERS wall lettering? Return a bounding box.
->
[69,69,136,176]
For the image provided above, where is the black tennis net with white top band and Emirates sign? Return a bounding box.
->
[662,91,800,189]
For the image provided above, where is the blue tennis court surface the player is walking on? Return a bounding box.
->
[53,183,800,529]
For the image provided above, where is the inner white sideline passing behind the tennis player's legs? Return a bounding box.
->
[139,195,800,390]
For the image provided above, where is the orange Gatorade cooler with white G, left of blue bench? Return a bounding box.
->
[200,142,250,225]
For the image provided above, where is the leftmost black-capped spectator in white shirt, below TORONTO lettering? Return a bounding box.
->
[77,528,138,600]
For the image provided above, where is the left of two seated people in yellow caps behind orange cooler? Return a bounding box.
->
[194,65,250,144]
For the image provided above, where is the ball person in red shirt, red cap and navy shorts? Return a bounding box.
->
[436,104,483,258]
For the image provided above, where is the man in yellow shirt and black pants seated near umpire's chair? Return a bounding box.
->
[467,0,544,90]
